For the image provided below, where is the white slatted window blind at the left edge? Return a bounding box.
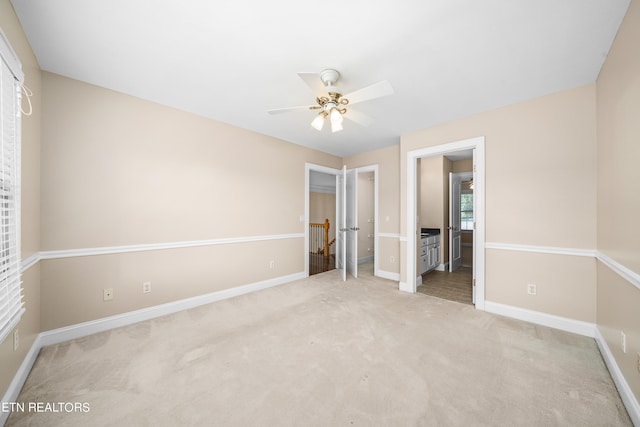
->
[0,29,24,342]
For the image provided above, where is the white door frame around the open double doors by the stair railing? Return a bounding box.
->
[300,162,380,277]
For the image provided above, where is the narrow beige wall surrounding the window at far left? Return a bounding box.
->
[0,0,42,402]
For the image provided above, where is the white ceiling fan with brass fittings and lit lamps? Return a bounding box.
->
[268,68,393,132]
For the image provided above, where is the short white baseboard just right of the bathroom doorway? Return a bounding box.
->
[484,301,596,338]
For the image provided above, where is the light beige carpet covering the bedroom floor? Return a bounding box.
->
[7,266,631,427]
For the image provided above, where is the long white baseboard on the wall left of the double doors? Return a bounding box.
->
[40,272,306,346]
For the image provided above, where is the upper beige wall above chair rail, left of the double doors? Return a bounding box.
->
[42,73,341,250]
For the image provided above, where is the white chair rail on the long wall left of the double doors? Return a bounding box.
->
[40,233,304,260]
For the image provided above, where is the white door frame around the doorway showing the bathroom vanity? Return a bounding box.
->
[399,136,485,310]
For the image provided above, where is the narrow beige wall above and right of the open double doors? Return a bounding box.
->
[344,145,402,274]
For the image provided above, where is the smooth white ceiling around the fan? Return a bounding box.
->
[12,0,630,156]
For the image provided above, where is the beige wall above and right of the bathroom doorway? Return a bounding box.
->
[400,85,596,322]
